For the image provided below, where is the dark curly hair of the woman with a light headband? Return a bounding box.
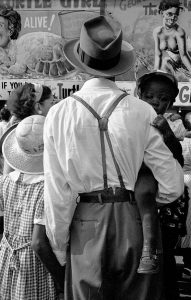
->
[7,83,51,120]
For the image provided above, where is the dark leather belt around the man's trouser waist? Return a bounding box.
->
[79,188,135,204]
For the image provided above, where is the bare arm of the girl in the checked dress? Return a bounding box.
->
[31,224,65,291]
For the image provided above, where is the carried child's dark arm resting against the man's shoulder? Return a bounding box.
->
[151,115,184,167]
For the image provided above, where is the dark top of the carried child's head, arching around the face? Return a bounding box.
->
[137,74,179,106]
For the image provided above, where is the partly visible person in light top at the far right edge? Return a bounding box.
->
[181,112,191,280]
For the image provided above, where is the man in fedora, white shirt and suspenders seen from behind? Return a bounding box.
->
[44,16,184,300]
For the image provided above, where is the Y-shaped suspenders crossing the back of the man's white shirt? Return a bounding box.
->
[71,93,127,189]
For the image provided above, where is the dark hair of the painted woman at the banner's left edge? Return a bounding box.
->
[0,5,21,40]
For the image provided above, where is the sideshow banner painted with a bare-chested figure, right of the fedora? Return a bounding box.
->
[105,0,191,82]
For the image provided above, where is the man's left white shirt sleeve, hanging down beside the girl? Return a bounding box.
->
[44,114,74,265]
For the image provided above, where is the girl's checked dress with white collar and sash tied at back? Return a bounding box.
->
[0,171,59,300]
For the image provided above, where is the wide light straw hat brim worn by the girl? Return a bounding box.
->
[2,128,44,174]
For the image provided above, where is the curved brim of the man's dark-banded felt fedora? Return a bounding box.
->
[64,39,136,77]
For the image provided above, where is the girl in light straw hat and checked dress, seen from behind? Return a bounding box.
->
[0,115,63,300]
